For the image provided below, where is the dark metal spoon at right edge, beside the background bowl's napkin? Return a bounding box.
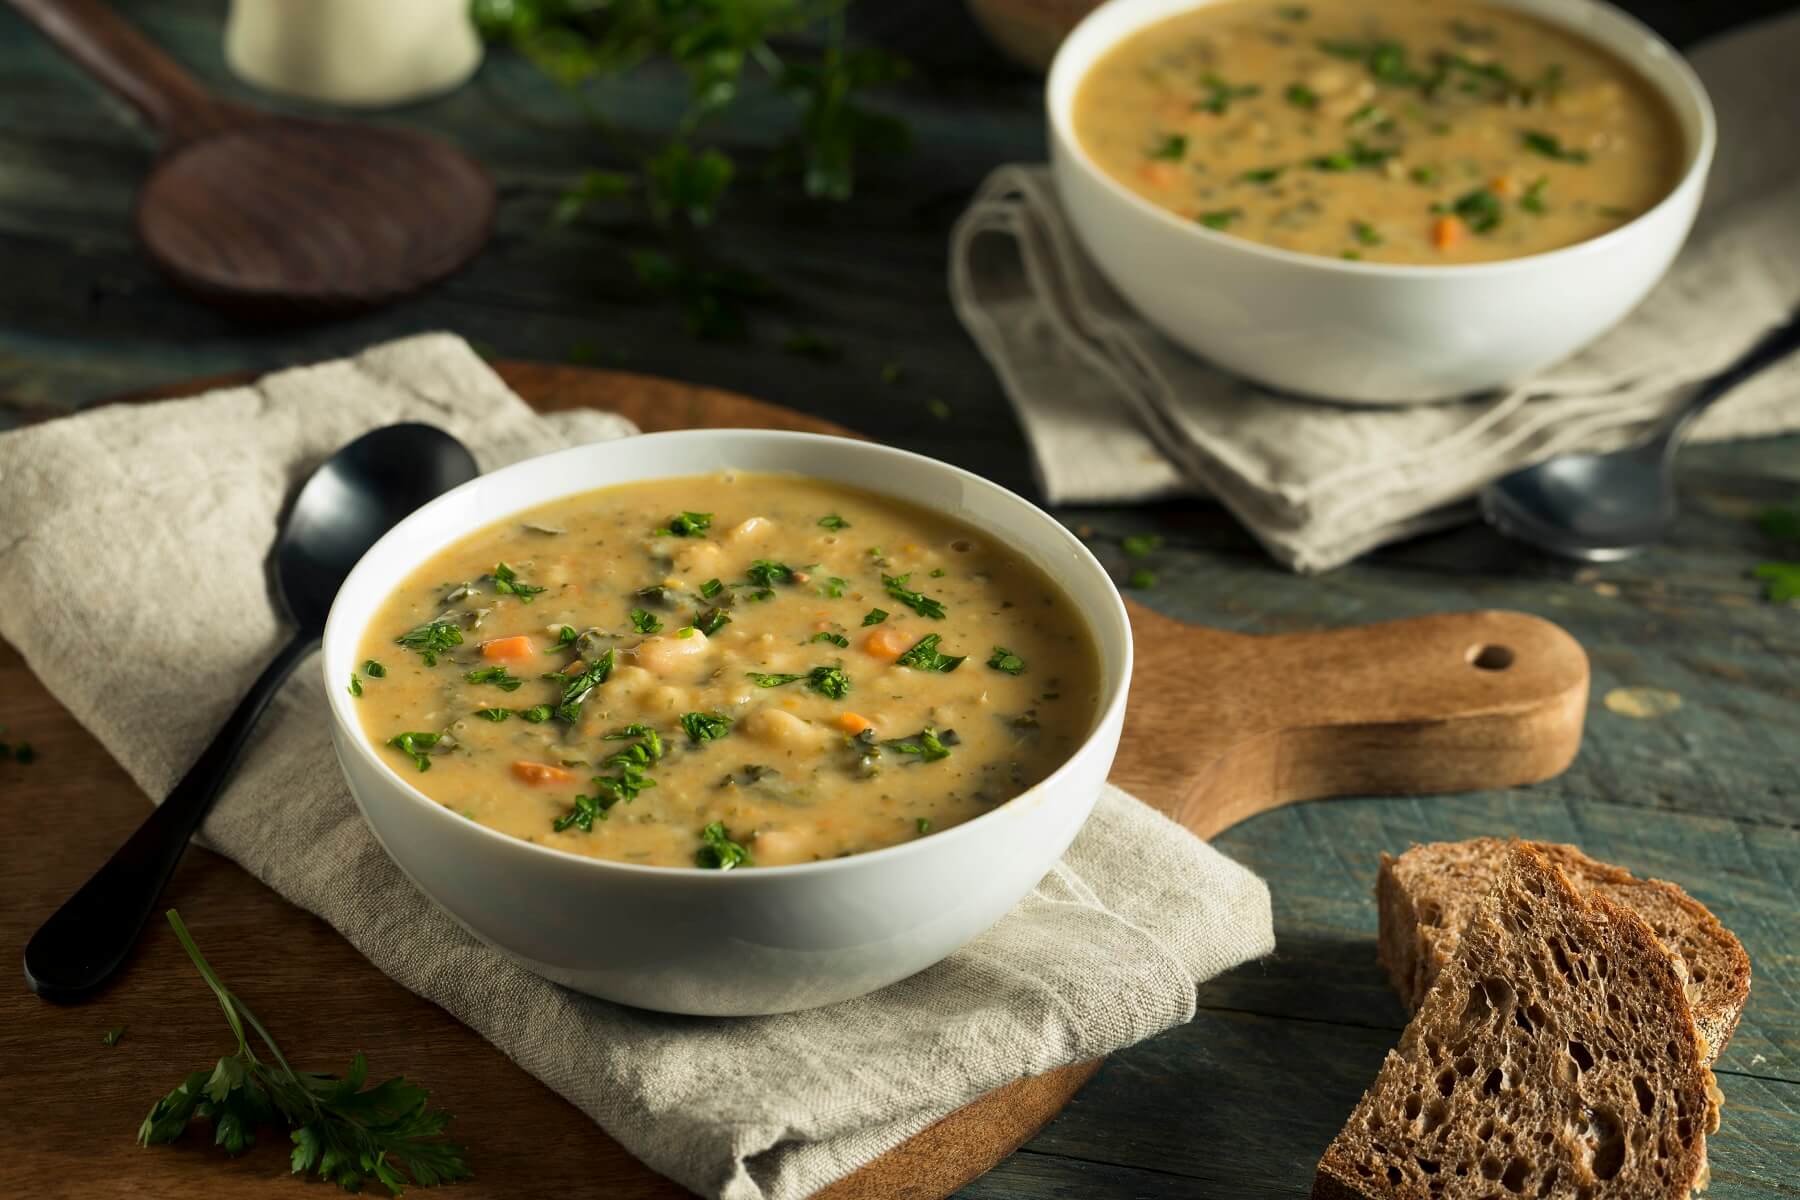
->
[1481,315,1800,563]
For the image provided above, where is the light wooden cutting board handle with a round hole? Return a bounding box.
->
[1112,603,1588,838]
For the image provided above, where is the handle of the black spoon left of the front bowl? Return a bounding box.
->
[25,633,319,1004]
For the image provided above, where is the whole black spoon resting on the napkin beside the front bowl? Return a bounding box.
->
[25,425,479,1004]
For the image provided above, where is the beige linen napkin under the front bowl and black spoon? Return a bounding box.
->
[0,335,1274,1200]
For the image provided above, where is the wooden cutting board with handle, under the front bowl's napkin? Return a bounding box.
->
[0,362,1588,1200]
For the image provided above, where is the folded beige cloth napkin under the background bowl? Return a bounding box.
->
[950,16,1800,570]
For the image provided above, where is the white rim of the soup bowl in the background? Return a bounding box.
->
[1044,0,1719,279]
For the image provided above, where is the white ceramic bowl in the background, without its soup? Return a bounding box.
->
[1046,0,1715,403]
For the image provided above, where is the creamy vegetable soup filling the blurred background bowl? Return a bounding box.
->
[1075,0,1685,263]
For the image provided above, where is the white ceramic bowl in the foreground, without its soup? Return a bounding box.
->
[322,430,1132,1015]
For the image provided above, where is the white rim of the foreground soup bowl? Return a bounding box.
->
[319,428,1136,887]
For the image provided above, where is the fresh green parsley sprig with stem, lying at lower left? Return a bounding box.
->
[138,909,470,1196]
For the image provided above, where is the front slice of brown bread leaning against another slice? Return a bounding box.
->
[1312,846,1719,1200]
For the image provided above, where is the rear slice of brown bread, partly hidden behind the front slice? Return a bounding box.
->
[1375,838,1750,1065]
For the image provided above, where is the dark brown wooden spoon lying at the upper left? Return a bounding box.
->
[11,0,493,320]
